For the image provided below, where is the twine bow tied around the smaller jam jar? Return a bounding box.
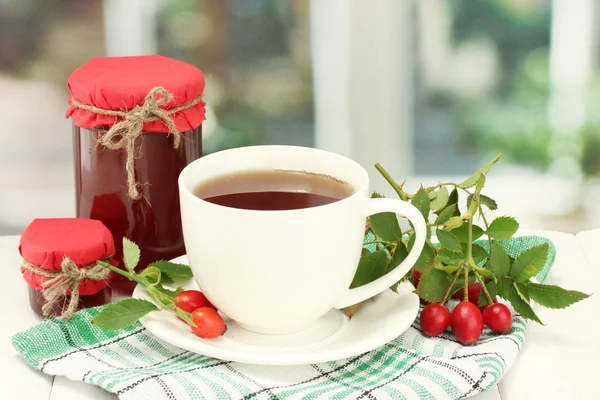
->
[23,256,110,319]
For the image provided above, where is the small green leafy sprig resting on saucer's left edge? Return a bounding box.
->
[92,238,195,330]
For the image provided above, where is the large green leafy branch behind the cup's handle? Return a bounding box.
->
[343,154,589,324]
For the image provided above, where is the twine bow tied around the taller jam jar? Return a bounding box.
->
[71,86,202,199]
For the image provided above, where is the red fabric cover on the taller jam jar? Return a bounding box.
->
[66,55,205,132]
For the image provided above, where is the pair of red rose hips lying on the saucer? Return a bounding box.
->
[175,290,227,339]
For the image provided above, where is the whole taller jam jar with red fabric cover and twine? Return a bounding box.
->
[67,55,205,293]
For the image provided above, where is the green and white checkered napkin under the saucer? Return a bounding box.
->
[13,237,555,400]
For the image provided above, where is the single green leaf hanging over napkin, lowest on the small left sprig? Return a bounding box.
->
[92,299,158,330]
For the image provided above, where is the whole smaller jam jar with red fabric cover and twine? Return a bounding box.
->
[19,218,115,318]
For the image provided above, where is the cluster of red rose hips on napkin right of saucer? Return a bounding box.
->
[421,282,512,345]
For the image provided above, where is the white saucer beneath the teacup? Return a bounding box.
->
[133,256,419,365]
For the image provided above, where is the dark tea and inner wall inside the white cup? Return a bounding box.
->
[194,171,353,211]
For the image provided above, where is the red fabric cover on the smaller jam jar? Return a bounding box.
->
[19,218,115,296]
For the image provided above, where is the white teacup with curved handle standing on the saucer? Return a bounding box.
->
[179,146,426,334]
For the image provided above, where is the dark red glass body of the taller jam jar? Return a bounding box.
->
[73,124,202,293]
